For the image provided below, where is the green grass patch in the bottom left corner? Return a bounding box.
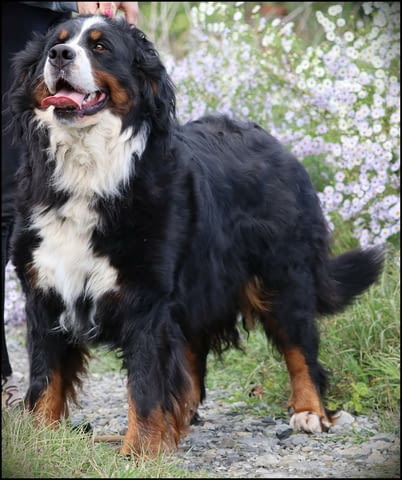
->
[2,409,210,478]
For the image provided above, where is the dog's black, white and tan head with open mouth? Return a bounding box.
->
[9,16,175,132]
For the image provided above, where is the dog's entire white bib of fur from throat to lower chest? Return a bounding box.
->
[31,112,147,330]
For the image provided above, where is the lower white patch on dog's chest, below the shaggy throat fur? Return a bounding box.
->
[32,198,117,305]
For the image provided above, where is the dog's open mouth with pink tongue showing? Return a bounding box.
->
[41,80,108,116]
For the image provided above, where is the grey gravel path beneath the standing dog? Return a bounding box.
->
[5,262,400,478]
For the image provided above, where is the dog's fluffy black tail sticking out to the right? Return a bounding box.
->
[317,247,385,314]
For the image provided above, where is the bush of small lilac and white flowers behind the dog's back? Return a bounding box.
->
[165,2,400,246]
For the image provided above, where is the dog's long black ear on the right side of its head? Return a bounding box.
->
[131,28,176,132]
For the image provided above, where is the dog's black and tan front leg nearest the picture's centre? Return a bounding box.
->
[120,320,200,456]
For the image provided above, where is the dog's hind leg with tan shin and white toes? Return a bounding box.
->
[246,275,331,432]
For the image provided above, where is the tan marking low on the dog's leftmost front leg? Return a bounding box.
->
[33,371,68,426]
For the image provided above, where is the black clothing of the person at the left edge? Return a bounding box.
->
[1,2,77,378]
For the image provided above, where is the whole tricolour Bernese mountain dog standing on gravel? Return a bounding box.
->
[5,16,384,455]
